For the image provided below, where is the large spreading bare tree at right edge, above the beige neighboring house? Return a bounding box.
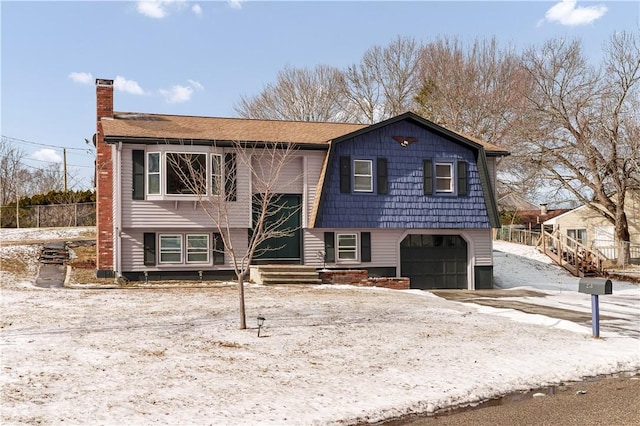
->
[521,33,640,265]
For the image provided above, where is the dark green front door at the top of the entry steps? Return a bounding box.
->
[253,194,302,263]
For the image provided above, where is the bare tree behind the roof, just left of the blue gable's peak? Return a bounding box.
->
[343,37,421,123]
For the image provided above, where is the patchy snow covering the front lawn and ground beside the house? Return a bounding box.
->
[0,231,640,425]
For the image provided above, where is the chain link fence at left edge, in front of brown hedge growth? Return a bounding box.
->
[0,202,96,228]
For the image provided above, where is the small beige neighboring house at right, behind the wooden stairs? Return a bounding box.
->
[544,191,640,259]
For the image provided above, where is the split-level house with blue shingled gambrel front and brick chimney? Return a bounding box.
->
[96,79,508,289]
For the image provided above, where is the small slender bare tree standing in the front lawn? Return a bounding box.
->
[168,142,300,329]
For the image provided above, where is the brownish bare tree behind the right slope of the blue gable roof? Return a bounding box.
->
[415,37,539,198]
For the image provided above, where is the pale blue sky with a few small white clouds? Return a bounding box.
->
[0,0,640,188]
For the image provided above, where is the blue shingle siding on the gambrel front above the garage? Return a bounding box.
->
[316,121,491,229]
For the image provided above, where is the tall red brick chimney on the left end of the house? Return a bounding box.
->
[96,78,115,278]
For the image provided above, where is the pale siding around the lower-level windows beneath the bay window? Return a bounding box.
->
[122,227,248,272]
